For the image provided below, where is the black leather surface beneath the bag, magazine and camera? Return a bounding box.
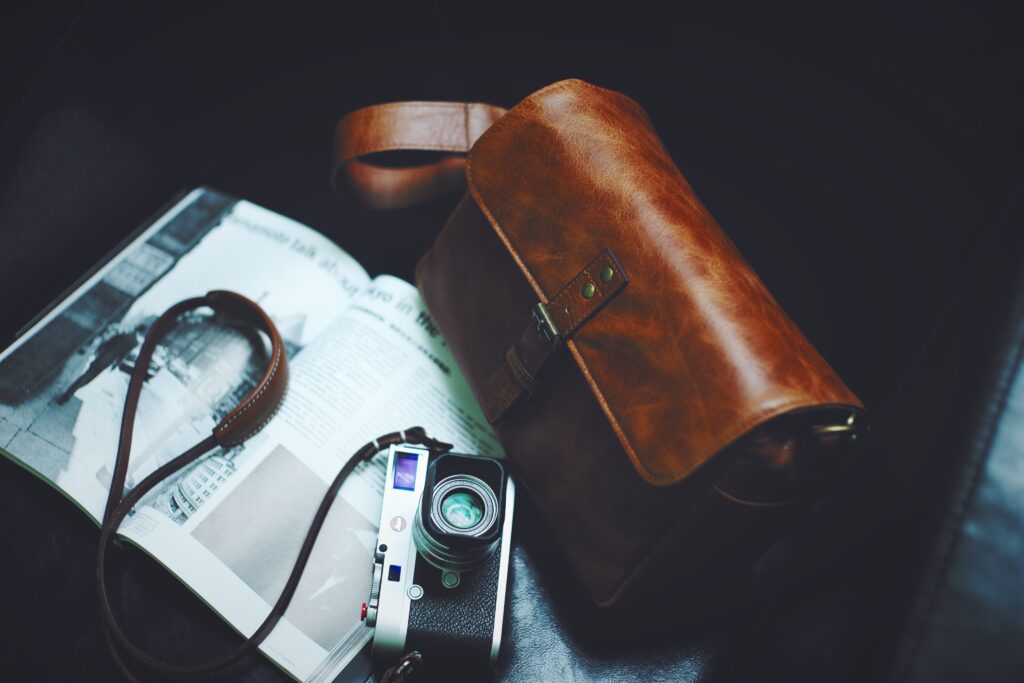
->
[0,2,1024,682]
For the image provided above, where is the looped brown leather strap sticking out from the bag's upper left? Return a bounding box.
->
[332,101,505,209]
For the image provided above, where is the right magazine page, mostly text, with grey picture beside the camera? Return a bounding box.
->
[122,275,501,681]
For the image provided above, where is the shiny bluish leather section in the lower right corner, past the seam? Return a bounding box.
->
[895,311,1024,683]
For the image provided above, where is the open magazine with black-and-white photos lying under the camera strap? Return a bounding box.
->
[0,188,501,681]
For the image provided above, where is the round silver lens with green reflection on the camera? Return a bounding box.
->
[413,474,501,572]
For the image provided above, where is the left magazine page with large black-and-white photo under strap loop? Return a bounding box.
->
[0,189,370,679]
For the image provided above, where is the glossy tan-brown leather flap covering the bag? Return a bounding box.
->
[466,80,862,485]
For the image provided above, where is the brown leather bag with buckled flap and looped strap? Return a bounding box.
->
[335,80,863,613]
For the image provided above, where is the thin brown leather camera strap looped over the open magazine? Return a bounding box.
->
[96,291,451,681]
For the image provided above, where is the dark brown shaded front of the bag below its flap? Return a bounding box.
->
[418,198,839,610]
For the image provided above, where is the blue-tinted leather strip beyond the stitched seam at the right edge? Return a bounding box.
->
[892,181,1024,683]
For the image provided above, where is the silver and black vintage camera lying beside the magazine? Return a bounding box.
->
[364,445,515,672]
